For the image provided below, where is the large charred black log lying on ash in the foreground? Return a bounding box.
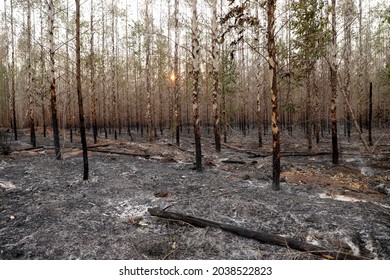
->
[148,208,361,260]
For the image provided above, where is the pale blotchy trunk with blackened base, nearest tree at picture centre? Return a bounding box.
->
[191,0,202,172]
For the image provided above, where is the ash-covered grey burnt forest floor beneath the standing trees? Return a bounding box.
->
[0,127,390,260]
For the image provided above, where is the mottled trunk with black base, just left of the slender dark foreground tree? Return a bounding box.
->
[47,0,62,160]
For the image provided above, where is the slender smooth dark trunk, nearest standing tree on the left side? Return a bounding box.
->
[75,0,89,180]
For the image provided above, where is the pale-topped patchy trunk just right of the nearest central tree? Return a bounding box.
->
[211,0,221,152]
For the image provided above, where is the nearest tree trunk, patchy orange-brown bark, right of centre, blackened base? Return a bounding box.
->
[267,0,280,191]
